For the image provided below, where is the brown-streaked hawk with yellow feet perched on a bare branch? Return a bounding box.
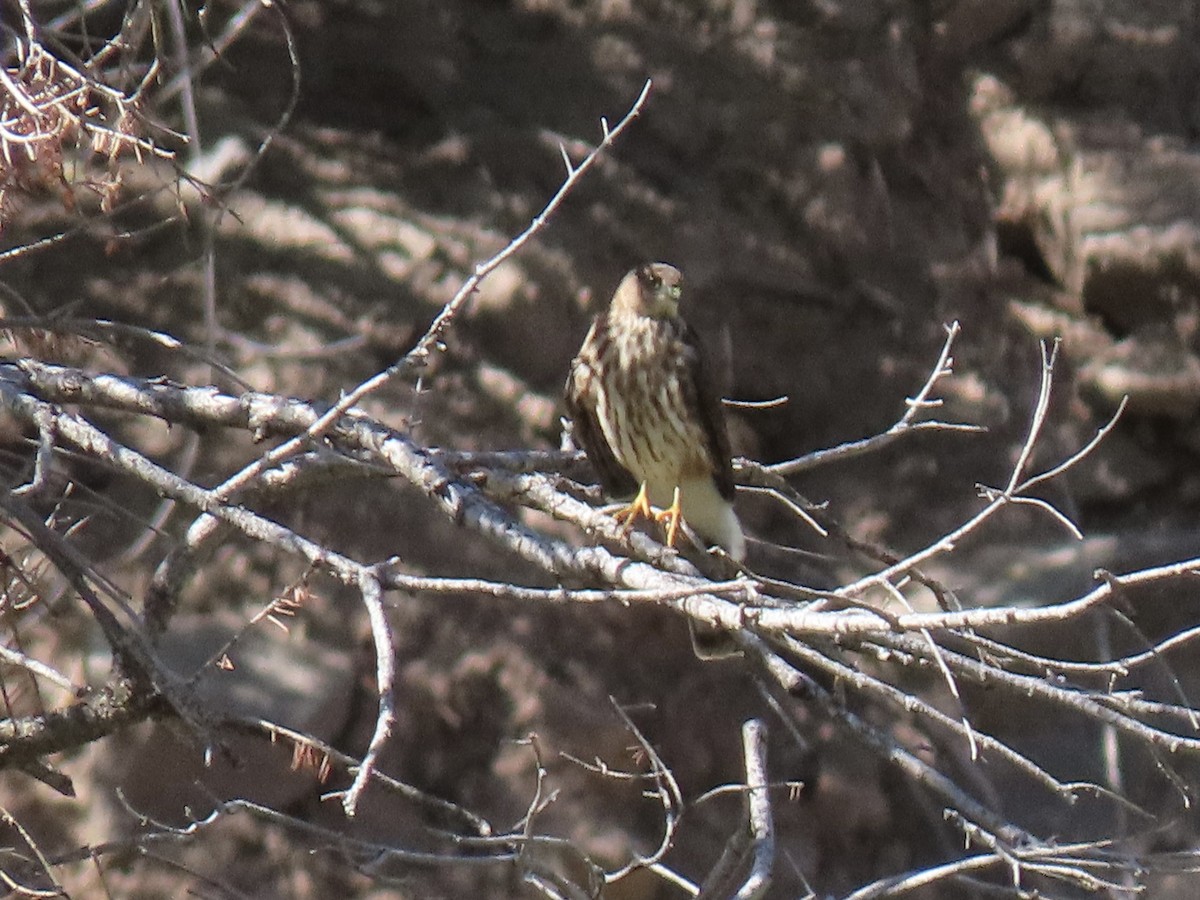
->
[566,263,745,560]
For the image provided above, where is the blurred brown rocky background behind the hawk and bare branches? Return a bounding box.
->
[7,0,1200,899]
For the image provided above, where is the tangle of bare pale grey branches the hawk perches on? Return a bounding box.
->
[0,3,1200,900]
